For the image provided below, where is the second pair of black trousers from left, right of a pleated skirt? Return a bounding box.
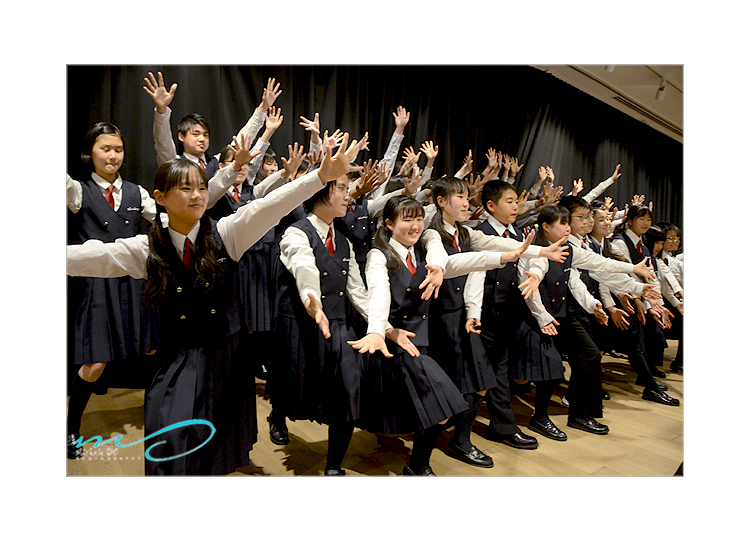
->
[552,313,602,418]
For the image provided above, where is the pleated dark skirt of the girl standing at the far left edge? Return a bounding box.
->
[68,277,159,365]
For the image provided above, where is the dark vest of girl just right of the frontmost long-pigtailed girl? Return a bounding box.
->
[278,218,350,320]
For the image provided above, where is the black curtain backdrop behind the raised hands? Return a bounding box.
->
[67,65,683,226]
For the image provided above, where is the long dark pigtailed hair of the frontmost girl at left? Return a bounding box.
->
[143,158,223,307]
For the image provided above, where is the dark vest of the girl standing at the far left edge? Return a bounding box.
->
[68,179,143,245]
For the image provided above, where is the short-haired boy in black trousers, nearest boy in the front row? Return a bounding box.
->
[466,180,539,450]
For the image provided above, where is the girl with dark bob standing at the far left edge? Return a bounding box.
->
[67,122,158,459]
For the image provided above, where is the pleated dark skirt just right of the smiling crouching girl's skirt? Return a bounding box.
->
[427,307,497,394]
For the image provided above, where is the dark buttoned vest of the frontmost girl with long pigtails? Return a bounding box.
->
[158,221,240,349]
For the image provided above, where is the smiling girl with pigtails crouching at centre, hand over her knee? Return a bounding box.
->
[350,195,528,476]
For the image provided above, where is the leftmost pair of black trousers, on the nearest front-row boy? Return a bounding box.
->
[479,307,519,435]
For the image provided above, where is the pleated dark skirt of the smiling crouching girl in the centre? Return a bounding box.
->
[357,343,468,435]
